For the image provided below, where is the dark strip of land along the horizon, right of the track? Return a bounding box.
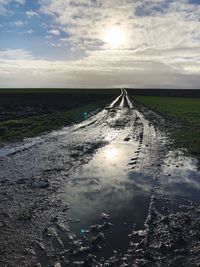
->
[128,89,200,97]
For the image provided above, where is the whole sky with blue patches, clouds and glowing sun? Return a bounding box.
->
[0,0,200,88]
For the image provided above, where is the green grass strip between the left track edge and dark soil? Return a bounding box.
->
[0,100,105,143]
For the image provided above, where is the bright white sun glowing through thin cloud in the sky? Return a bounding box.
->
[105,26,126,48]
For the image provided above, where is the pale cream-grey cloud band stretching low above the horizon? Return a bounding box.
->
[0,49,200,88]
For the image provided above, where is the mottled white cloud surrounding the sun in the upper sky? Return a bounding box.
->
[40,0,200,51]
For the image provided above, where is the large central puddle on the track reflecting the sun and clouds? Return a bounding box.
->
[65,142,151,256]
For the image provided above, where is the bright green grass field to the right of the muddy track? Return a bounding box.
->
[134,96,200,164]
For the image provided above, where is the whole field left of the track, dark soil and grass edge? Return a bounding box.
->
[0,89,120,143]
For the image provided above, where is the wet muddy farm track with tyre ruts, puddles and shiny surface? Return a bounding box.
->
[0,90,200,267]
